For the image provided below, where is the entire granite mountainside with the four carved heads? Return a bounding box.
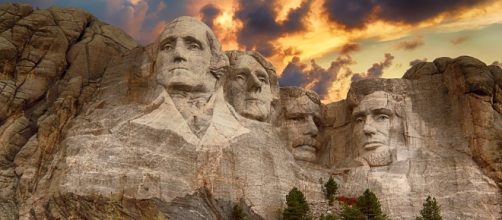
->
[0,4,502,219]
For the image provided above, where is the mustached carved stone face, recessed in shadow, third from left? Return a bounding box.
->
[283,95,321,162]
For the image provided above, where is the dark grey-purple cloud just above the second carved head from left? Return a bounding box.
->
[235,0,312,57]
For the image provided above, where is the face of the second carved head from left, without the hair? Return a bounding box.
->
[225,54,273,121]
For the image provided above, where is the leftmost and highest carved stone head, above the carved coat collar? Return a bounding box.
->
[155,19,216,93]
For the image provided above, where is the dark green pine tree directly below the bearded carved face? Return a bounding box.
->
[357,189,387,220]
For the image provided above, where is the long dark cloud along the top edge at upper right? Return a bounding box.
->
[323,0,489,29]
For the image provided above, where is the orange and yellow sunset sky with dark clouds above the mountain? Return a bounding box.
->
[0,0,502,103]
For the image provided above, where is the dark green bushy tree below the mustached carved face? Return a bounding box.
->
[283,187,310,220]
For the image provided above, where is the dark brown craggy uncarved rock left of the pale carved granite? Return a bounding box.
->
[0,4,136,219]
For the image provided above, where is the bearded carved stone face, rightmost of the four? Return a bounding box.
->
[352,91,394,166]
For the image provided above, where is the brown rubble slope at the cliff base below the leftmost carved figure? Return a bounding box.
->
[40,189,263,220]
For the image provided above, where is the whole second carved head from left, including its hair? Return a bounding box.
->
[225,51,278,121]
